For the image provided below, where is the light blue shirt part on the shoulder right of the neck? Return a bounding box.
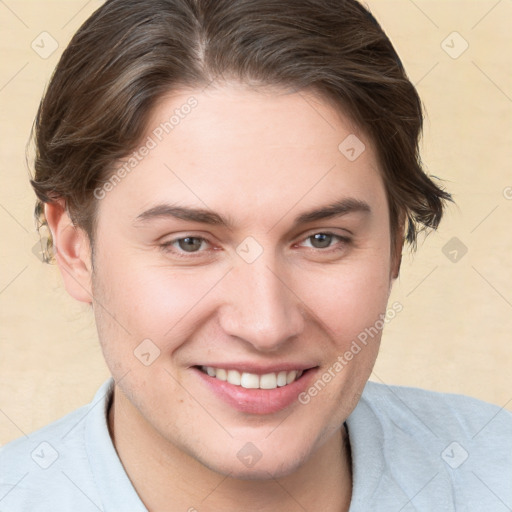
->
[347,382,512,511]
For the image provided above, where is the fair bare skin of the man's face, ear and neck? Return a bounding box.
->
[46,83,401,512]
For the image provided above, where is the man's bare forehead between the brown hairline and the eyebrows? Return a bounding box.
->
[102,85,383,226]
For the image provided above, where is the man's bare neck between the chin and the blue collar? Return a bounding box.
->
[108,388,352,512]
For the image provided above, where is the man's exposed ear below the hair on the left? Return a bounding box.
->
[44,200,92,304]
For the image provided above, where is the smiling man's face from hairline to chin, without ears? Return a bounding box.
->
[93,85,393,478]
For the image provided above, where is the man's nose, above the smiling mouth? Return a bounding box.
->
[220,257,304,352]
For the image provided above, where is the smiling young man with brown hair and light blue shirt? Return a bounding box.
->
[0,0,512,512]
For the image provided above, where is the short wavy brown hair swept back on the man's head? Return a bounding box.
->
[31,0,451,262]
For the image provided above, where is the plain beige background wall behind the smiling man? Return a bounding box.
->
[0,0,512,444]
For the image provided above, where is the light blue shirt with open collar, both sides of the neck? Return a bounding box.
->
[0,380,512,512]
